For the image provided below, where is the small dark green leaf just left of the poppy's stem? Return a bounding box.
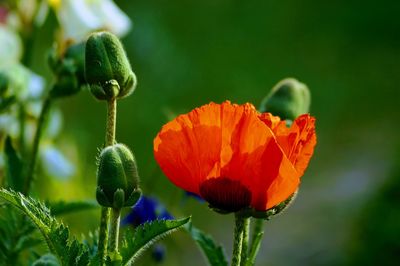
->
[186,225,228,266]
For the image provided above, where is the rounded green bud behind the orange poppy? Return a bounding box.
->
[259,78,311,120]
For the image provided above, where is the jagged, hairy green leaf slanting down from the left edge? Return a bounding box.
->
[0,188,89,266]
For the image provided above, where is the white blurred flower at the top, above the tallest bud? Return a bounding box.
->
[49,0,132,42]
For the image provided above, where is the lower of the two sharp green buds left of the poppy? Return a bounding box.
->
[96,144,141,209]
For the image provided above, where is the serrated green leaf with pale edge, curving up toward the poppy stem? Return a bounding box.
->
[120,217,191,265]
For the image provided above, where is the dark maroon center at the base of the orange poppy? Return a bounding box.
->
[200,177,251,212]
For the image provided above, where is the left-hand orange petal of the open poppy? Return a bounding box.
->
[154,103,221,194]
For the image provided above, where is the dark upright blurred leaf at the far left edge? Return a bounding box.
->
[4,136,24,191]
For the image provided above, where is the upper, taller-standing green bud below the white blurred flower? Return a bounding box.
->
[85,32,136,100]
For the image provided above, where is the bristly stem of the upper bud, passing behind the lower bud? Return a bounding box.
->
[98,99,117,265]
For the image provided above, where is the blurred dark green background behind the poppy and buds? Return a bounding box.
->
[28,0,400,266]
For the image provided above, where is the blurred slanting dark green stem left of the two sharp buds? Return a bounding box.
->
[22,97,52,195]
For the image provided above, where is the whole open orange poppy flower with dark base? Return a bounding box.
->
[154,101,316,211]
